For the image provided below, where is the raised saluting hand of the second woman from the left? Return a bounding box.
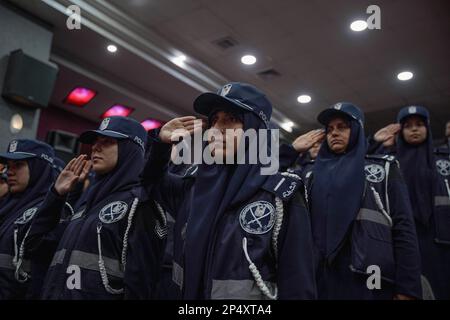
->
[55,154,91,196]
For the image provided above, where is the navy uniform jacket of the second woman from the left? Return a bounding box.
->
[27,188,166,299]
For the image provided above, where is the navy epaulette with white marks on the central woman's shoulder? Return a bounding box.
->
[262,172,303,200]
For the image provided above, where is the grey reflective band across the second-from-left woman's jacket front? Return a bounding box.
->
[69,250,123,278]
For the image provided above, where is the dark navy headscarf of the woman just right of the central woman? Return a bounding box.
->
[311,117,367,257]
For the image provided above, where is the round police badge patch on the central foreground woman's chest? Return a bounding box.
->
[239,201,275,234]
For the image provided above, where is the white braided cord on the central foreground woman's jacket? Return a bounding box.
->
[242,197,283,300]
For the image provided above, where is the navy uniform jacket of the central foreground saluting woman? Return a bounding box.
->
[144,142,316,299]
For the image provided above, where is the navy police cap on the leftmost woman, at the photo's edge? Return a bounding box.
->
[0,139,55,165]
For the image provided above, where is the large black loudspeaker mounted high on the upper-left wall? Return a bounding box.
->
[2,49,58,108]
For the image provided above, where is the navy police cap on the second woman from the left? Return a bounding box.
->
[80,116,147,150]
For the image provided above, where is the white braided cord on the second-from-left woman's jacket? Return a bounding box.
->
[97,198,139,294]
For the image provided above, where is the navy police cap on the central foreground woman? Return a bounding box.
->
[194,82,272,125]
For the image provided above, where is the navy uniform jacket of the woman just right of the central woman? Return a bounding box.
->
[307,155,422,299]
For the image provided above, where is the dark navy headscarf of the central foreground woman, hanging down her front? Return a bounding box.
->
[184,112,270,299]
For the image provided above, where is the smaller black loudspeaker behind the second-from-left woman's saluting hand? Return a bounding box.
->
[47,130,79,164]
